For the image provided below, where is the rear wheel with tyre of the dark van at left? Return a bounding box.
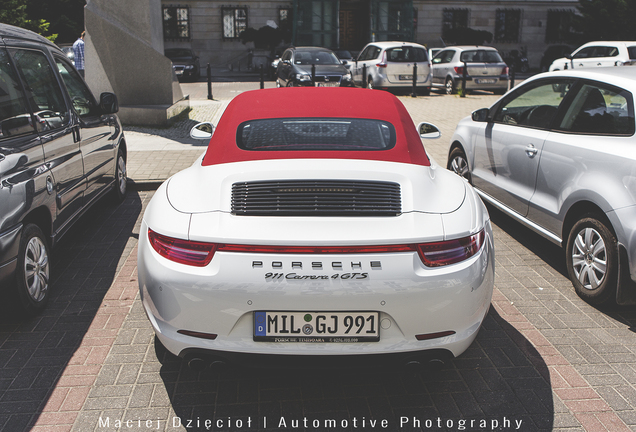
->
[15,224,51,315]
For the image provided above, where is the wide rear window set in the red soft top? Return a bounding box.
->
[236,118,395,151]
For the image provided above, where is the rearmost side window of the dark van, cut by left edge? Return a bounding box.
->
[0,49,35,140]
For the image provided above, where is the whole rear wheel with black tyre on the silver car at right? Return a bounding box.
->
[565,214,618,305]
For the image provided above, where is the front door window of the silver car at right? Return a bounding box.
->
[494,80,574,129]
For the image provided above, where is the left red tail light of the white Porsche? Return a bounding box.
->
[148,229,218,267]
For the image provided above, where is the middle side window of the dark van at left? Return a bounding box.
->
[11,49,69,132]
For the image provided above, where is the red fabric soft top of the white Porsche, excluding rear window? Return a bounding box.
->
[203,87,430,166]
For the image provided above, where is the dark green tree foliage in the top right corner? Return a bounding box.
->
[574,0,636,42]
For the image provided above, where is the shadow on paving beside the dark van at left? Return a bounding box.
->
[0,192,142,432]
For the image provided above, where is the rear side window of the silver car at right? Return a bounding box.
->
[559,83,635,136]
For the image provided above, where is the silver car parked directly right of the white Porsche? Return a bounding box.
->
[448,67,636,304]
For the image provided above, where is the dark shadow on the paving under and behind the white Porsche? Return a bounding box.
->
[156,308,554,431]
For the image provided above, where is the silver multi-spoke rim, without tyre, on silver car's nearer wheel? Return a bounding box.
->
[571,227,607,290]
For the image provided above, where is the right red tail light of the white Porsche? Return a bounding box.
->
[417,230,486,267]
